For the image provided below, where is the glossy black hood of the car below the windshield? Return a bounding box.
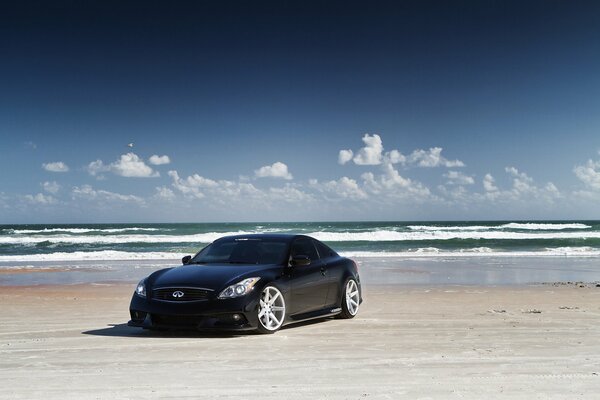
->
[148,264,281,290]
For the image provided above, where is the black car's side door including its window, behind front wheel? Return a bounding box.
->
[289,238,329,315]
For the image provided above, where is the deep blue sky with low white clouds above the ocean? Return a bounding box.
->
[0,1,600,223]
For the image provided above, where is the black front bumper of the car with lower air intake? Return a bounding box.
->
[127,291,259,331]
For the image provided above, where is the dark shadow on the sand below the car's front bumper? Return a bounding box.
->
[81,324,244,339]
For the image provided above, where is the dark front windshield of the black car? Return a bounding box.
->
[190,239,288,264]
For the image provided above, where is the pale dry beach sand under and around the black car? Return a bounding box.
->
[0,285,600,399]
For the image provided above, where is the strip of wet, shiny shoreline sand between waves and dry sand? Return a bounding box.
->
[0,257,600,287]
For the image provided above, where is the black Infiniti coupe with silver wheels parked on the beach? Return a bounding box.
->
[129,234,362,333]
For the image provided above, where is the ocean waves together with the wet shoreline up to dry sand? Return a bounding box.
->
[0,221,600,286]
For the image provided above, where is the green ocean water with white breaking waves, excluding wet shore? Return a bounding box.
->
[0,221,600,264]
